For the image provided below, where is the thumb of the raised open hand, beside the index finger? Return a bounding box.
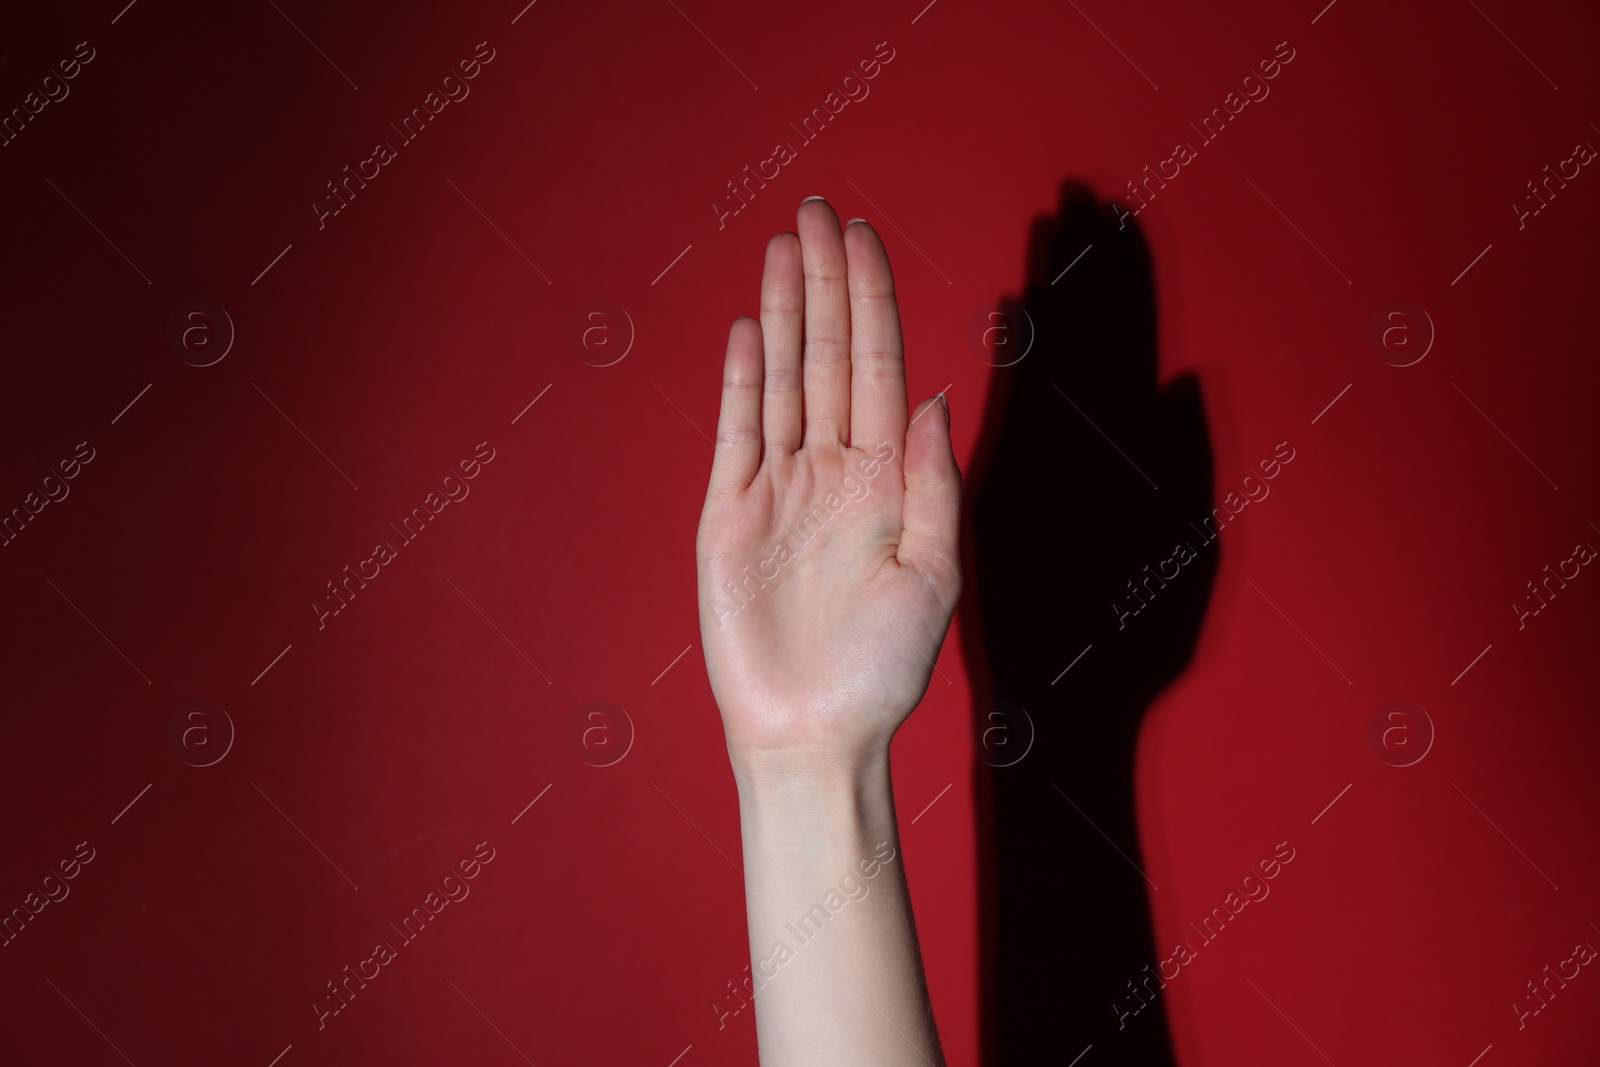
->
[899,394,962,585]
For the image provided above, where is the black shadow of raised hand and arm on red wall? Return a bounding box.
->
[962,181,1218,1067]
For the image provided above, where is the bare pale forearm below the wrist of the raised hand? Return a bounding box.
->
[734,752,944,1067]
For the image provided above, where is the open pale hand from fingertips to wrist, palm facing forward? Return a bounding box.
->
[696,200,962,773]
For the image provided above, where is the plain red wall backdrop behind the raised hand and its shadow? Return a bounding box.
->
[0,0,1600,1067]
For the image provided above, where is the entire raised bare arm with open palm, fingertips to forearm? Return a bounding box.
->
[696,200,962,1067]
